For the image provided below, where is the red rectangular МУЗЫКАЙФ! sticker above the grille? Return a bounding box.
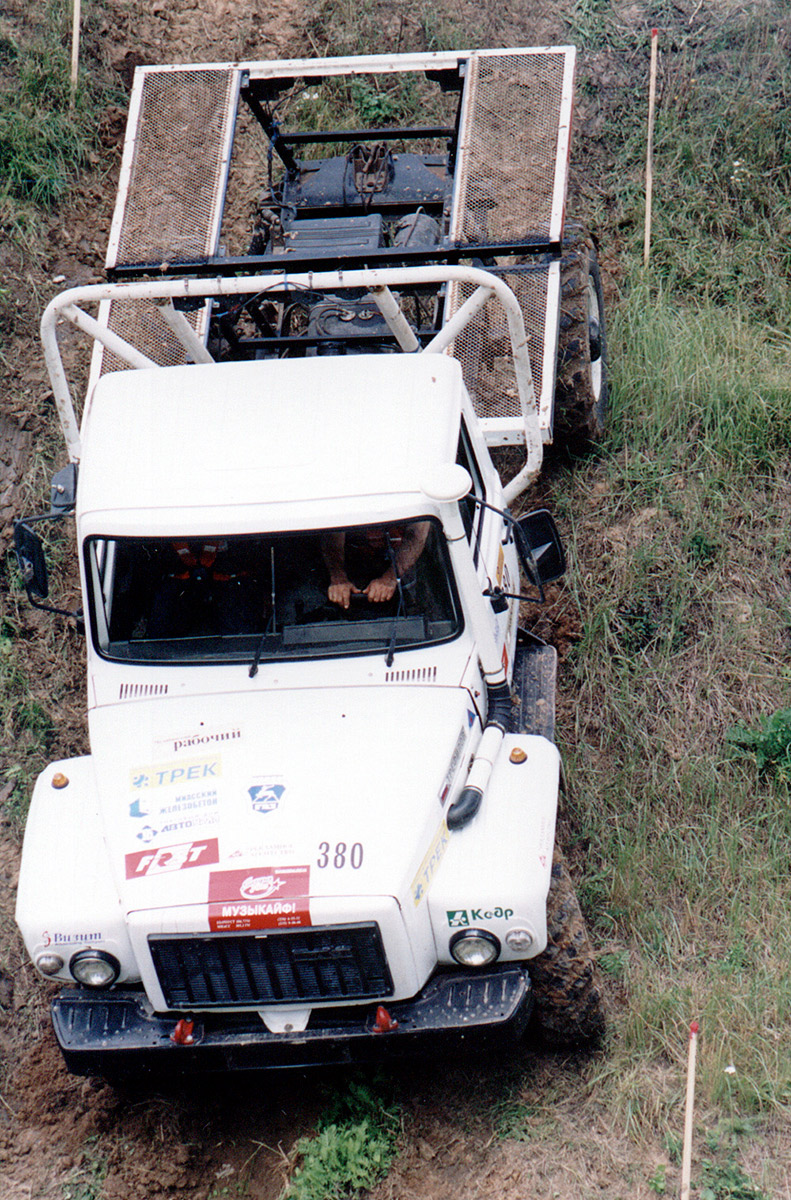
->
[209,866,311,932]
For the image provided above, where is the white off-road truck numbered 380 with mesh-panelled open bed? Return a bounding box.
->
[16,48,606,1075]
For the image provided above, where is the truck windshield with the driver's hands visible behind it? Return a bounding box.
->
[85,517,462,664]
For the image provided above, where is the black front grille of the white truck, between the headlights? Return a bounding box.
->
[149,922,392,1009]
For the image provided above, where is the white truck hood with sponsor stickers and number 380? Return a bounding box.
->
[91,685,479,929]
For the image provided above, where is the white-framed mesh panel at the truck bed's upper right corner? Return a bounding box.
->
[450,47,575,245]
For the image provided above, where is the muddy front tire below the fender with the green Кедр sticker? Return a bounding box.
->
[529,850,605,1048]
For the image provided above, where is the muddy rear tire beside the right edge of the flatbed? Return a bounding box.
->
[553,230,607,451]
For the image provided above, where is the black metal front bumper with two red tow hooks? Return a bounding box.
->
[52,966,533,1076]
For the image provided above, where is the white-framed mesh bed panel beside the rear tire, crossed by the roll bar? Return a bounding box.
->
[448,260,561,445]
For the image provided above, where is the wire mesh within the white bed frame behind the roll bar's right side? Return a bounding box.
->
[449,263,553,420]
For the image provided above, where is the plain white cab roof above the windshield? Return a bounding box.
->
[78,354,465,532]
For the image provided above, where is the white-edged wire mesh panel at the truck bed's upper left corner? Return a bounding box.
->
[107,70,236,266]
